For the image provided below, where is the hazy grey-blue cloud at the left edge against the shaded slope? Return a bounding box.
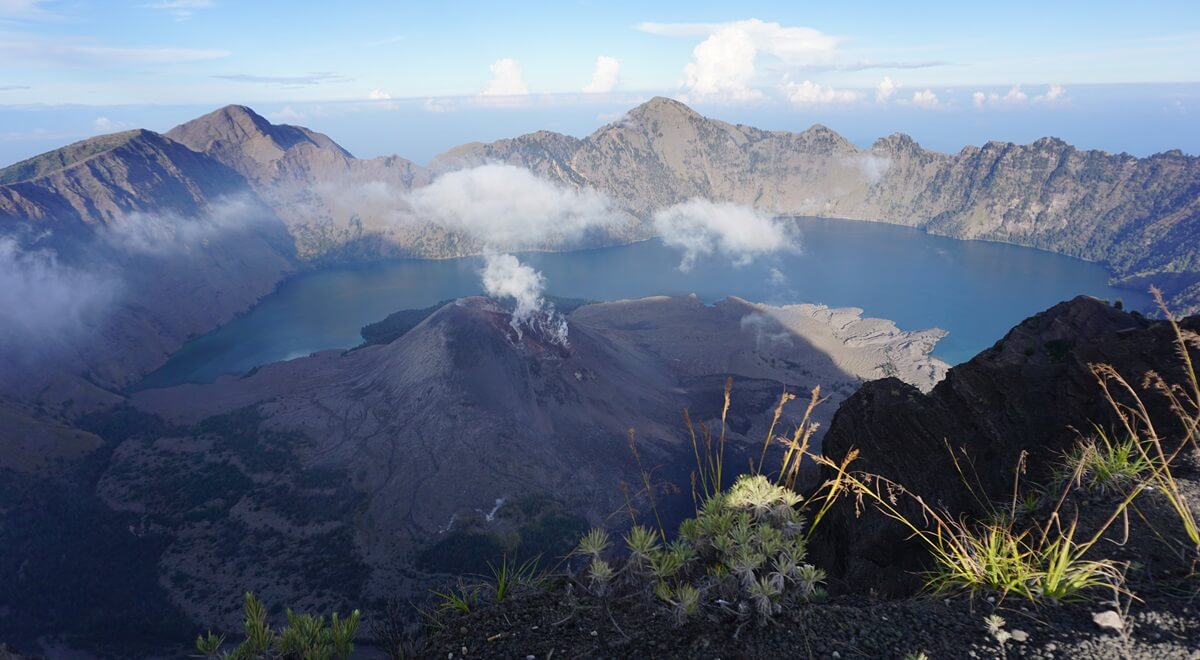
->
[0,236,119,348]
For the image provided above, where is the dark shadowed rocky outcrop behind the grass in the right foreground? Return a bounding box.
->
[814,296,1200,593]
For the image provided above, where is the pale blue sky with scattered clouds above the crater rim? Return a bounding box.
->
[0,0,1200,162]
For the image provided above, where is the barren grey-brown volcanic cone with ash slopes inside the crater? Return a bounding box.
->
[112,298,946,625]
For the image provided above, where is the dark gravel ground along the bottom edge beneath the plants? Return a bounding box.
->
[421,583,1200,660]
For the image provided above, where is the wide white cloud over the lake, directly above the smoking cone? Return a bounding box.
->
[408,163,619,251]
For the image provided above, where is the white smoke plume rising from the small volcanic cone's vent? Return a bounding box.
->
[480,254,568,347]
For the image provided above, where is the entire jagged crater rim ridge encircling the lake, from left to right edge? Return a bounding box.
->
[0,97,1200,410]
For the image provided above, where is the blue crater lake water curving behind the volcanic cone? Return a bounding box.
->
[139,218,1150,388]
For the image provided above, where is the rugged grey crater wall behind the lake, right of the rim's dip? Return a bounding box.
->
[432,97,1200,312]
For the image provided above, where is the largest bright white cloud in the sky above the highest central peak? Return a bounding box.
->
[637,18,841,101]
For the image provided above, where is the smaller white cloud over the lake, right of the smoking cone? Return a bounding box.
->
[654,198,799,272]
